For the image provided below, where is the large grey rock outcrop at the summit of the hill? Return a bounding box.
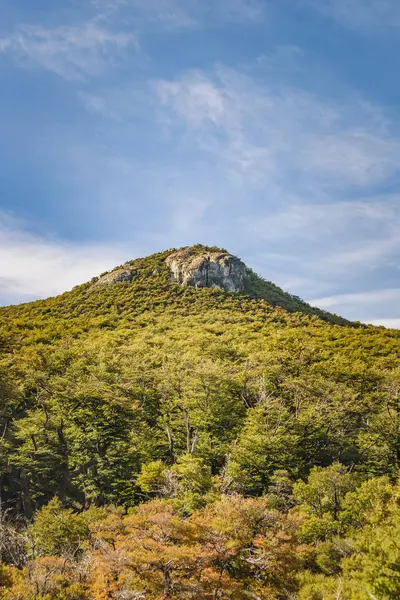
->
[165,248,246,292]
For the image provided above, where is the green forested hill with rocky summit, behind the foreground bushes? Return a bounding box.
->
[0,246,400,515]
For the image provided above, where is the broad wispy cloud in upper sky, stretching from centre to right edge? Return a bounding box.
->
[155,68,400,194]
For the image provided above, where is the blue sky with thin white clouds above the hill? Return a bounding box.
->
[0,0,400,328]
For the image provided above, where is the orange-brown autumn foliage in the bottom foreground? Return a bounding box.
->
[6,496,301,600]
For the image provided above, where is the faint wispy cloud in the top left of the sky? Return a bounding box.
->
[0,22,137,79]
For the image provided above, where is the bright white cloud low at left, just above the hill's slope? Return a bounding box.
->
[0,213,132,304]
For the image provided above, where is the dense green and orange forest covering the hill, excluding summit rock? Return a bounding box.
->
[0,246,400,600]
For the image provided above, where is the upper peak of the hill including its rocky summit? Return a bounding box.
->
[0,244,350,325]
